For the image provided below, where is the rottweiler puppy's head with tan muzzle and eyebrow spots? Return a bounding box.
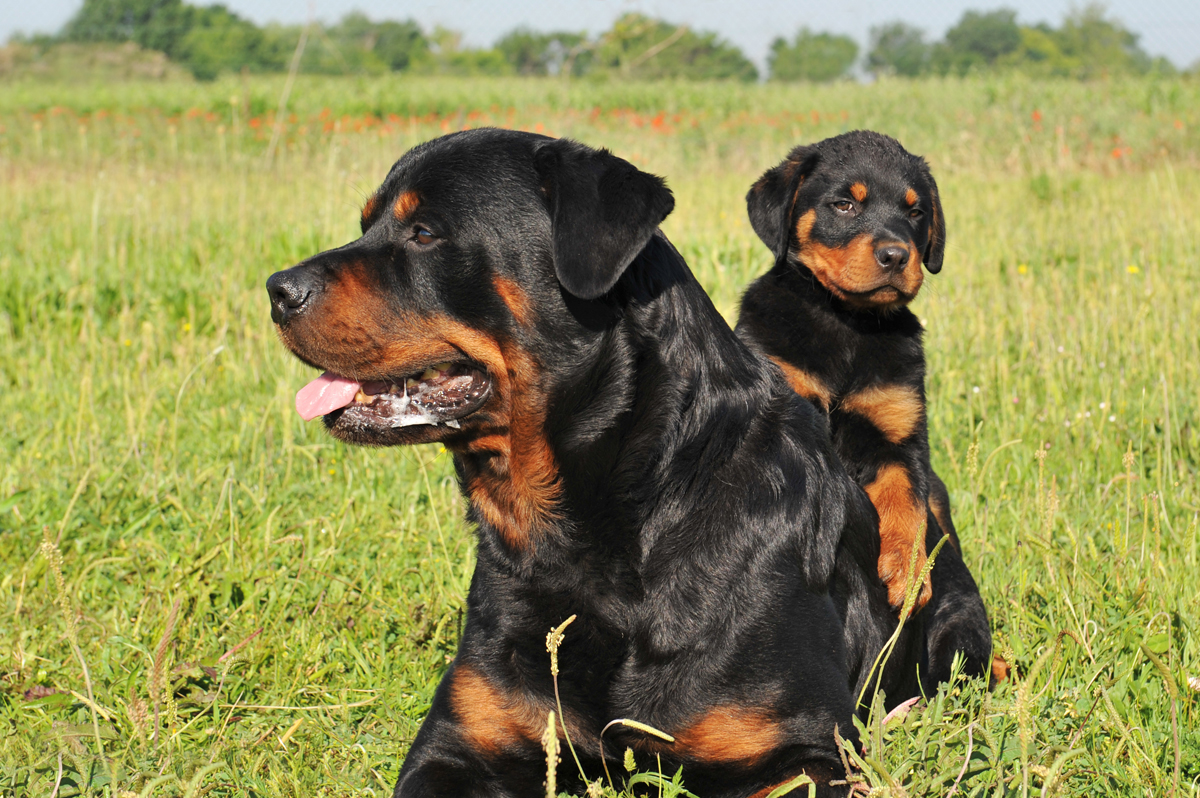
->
[746,131,946,312]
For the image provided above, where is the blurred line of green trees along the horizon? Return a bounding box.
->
[18,0,1175,82]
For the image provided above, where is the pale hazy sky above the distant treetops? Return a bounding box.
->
[7,0,1200,67]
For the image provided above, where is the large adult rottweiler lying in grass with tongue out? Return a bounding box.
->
[268,130,916,798]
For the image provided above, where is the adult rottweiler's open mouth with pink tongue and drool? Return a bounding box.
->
[296,362,492,428]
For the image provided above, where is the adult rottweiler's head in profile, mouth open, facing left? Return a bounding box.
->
[266,130,673,449]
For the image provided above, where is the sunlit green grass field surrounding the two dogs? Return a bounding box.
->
[0,78,1200,798]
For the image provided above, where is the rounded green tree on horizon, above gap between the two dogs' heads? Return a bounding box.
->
[595,12,758,80]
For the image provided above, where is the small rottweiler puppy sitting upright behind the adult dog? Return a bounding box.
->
[737,131,1002,686]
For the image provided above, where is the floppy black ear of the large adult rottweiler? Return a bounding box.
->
[534,139,674,299]
